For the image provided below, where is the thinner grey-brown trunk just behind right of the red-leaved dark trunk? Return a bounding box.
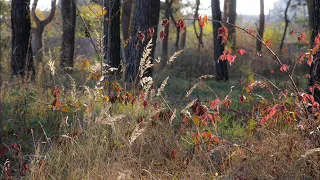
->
[223,0,237,49]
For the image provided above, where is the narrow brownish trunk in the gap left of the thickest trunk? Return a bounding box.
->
[121,0,133,59]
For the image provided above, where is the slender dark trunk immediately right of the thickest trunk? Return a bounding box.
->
[161,0,173,68]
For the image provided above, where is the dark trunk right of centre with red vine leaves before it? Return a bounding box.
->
[211,0,229,81]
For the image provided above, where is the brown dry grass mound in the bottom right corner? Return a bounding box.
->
[227,132,320,179]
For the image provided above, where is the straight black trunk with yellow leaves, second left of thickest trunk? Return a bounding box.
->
[104,0,121,68]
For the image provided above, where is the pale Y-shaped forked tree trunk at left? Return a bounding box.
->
[31,0,56,62]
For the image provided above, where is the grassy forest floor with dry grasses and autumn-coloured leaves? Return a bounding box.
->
[0,65,320,179]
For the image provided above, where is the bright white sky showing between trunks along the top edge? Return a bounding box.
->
[31,0,278,15]
